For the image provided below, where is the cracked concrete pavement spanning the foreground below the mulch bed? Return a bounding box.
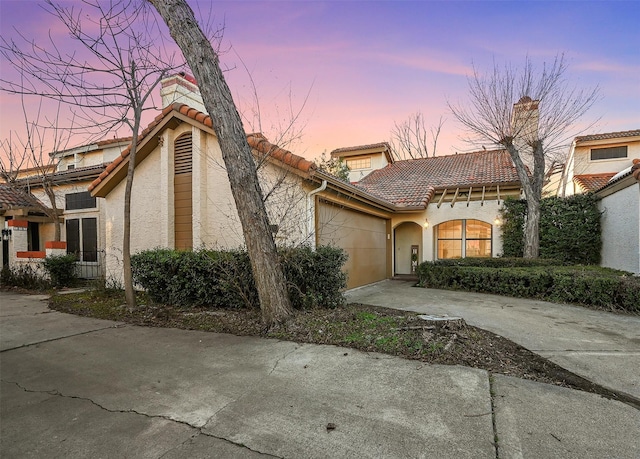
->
[0,292,640,458]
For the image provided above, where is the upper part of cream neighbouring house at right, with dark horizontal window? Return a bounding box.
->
[545,129,640,196]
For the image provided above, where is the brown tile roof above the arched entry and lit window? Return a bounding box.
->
[357,150,520,207]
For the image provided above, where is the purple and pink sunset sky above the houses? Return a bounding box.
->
[0,0,640,158]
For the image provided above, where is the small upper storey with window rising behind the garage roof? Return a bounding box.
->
[331,142,394,183]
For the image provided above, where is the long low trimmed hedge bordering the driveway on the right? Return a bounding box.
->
[418,258,640,313]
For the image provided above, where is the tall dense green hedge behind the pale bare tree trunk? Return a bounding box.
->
[502,194,602,265]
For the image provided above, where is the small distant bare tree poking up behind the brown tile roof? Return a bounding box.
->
[391,112,444,159]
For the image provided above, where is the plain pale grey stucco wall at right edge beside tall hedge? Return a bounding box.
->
[598,182,640,274]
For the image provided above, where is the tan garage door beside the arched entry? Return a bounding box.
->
[317,201,387,288]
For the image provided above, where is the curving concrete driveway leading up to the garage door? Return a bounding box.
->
[347,281,640,400]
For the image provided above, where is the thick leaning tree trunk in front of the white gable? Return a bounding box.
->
[149,0,293,326]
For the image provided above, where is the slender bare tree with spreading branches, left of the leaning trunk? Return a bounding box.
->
[0,0,178,307]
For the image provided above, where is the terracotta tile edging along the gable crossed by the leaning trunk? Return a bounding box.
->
[89,102,315,191]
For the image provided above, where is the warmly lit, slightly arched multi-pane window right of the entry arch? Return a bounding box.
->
[436,220,492,259]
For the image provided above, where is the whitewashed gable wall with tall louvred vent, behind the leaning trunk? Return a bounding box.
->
[104,123,308,280]
